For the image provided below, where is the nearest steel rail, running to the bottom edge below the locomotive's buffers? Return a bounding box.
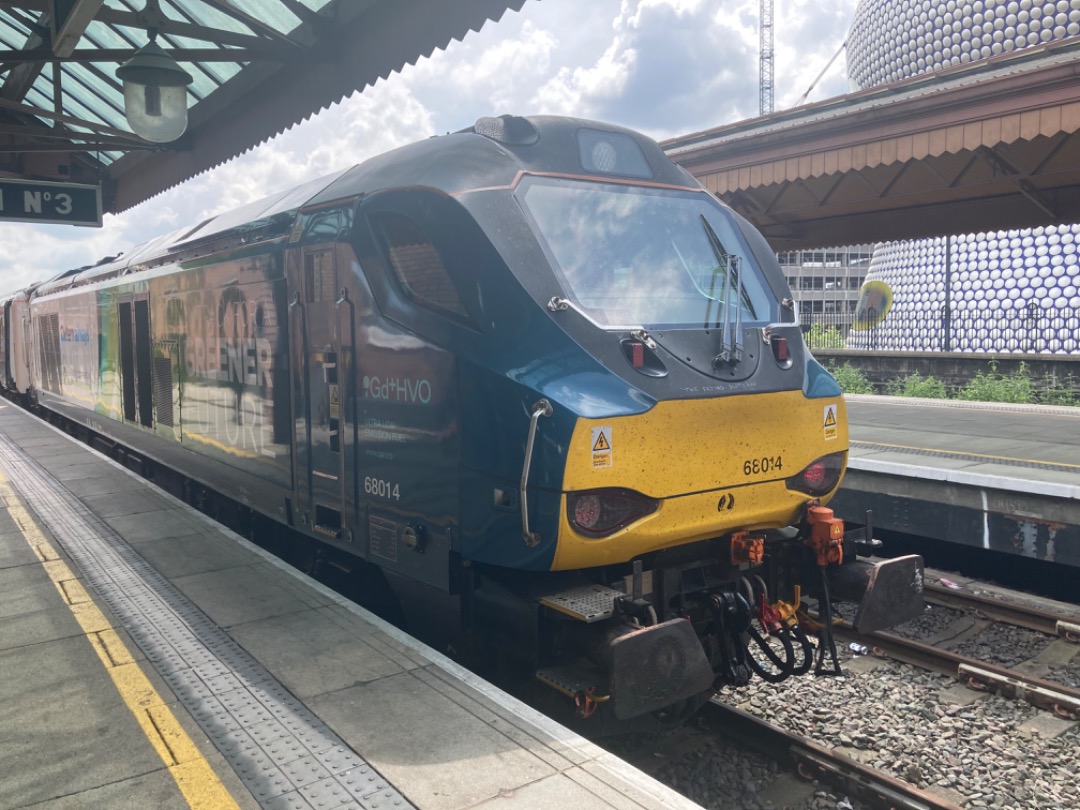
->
[703,698,959,810]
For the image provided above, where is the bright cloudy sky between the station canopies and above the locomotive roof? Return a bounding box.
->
[0,0,858,294]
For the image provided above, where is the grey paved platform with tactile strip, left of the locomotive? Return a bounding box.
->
[0,403,698,810]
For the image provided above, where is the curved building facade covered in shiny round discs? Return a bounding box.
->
[846,0,1080,353]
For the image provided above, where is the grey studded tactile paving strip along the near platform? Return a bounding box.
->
[0,434,414,810]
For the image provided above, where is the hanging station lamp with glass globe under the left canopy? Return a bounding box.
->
[117,30,192,144]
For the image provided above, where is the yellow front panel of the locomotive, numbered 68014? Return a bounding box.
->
[552,391,848,570]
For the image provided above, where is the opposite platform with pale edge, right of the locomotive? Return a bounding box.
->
[829,395,1080,566]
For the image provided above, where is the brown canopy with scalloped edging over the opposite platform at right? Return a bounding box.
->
[661,37,1080,251]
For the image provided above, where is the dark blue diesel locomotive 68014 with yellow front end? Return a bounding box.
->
[0,116,922,729]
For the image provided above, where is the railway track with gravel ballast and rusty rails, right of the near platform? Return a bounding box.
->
[636,583,1080,810]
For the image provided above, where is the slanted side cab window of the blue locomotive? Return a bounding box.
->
[369,212,469,318]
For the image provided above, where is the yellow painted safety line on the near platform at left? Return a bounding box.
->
[0,474,239,810]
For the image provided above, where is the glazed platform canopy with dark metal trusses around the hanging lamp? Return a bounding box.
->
[0,0,525,213]
